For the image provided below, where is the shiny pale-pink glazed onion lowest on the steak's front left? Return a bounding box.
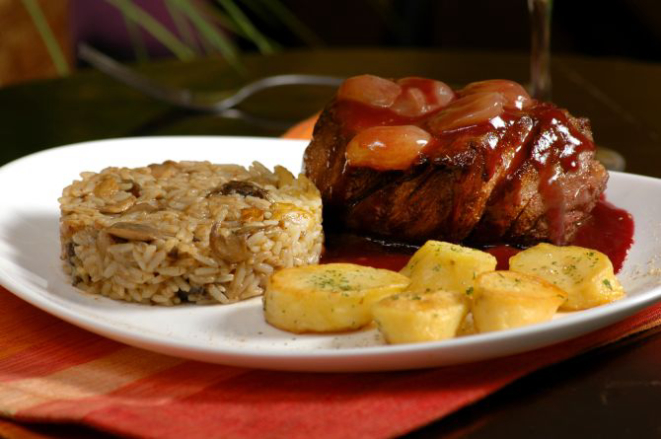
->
[346,125,431,171]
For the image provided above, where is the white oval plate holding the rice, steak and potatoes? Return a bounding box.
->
[0,137,661,371]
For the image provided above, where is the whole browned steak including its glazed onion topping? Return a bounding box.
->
[304,75,608,245]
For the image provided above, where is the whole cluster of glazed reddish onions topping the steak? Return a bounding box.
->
[337,75,536,170]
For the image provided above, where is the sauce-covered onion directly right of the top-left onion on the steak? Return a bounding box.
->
[390,77,454,117]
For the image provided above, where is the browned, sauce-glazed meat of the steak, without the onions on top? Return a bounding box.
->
[304,85,608,245]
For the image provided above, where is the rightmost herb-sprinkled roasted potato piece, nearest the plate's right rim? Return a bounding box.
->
[510,244,624,310]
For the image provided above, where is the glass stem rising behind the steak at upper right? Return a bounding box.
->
[528,0,553,101]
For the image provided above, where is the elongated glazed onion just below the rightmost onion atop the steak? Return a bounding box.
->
[429,92,505,133]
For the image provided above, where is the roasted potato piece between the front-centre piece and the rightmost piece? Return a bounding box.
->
[472,271,567,332]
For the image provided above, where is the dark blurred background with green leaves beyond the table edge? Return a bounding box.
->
[0,0,661,87]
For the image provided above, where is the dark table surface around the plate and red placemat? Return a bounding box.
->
[0,49,661,438]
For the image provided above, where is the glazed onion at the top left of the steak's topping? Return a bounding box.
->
[337,75,402,108]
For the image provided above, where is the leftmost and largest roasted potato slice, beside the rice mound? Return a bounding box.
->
[264,263,409,333]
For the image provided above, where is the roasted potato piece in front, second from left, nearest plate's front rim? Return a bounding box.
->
[372,290,469,343]
